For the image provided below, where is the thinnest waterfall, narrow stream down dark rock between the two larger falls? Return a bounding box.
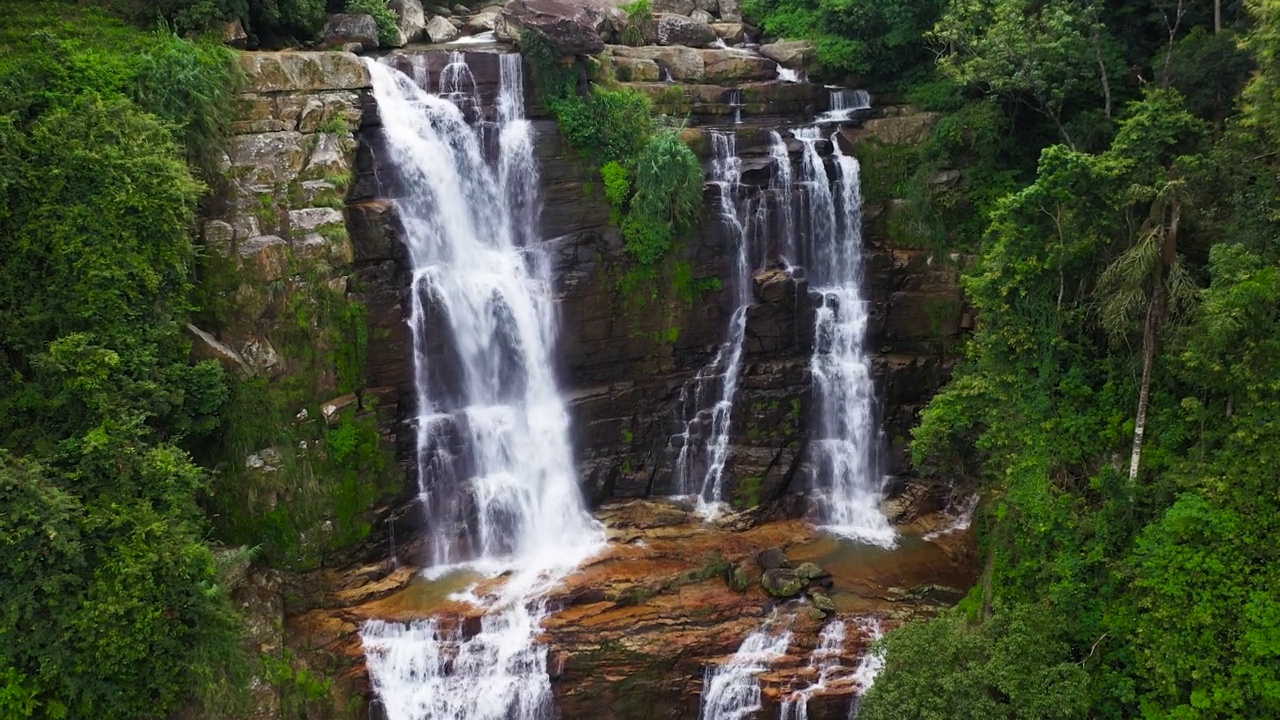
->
[673,132,754,518]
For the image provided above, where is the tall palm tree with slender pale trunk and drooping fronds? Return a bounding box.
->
[1097,181,1196,487]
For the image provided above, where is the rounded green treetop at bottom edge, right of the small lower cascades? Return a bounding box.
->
[858,605,1089,720]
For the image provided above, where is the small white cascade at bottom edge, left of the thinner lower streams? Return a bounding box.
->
[698,623,791,720]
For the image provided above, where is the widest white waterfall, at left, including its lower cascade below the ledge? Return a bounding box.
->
[361,53,602,720]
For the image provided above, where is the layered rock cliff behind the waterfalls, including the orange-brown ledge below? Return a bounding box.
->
[192,33,972,719]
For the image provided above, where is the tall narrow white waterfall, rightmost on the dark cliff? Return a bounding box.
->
[795,128,897,547]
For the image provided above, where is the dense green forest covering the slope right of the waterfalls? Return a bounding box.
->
[768,0,1280,720]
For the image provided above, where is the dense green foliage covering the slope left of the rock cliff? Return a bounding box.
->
[0,4,243,719]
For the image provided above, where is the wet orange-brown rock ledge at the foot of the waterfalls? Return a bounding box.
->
[287,501,975,720]
